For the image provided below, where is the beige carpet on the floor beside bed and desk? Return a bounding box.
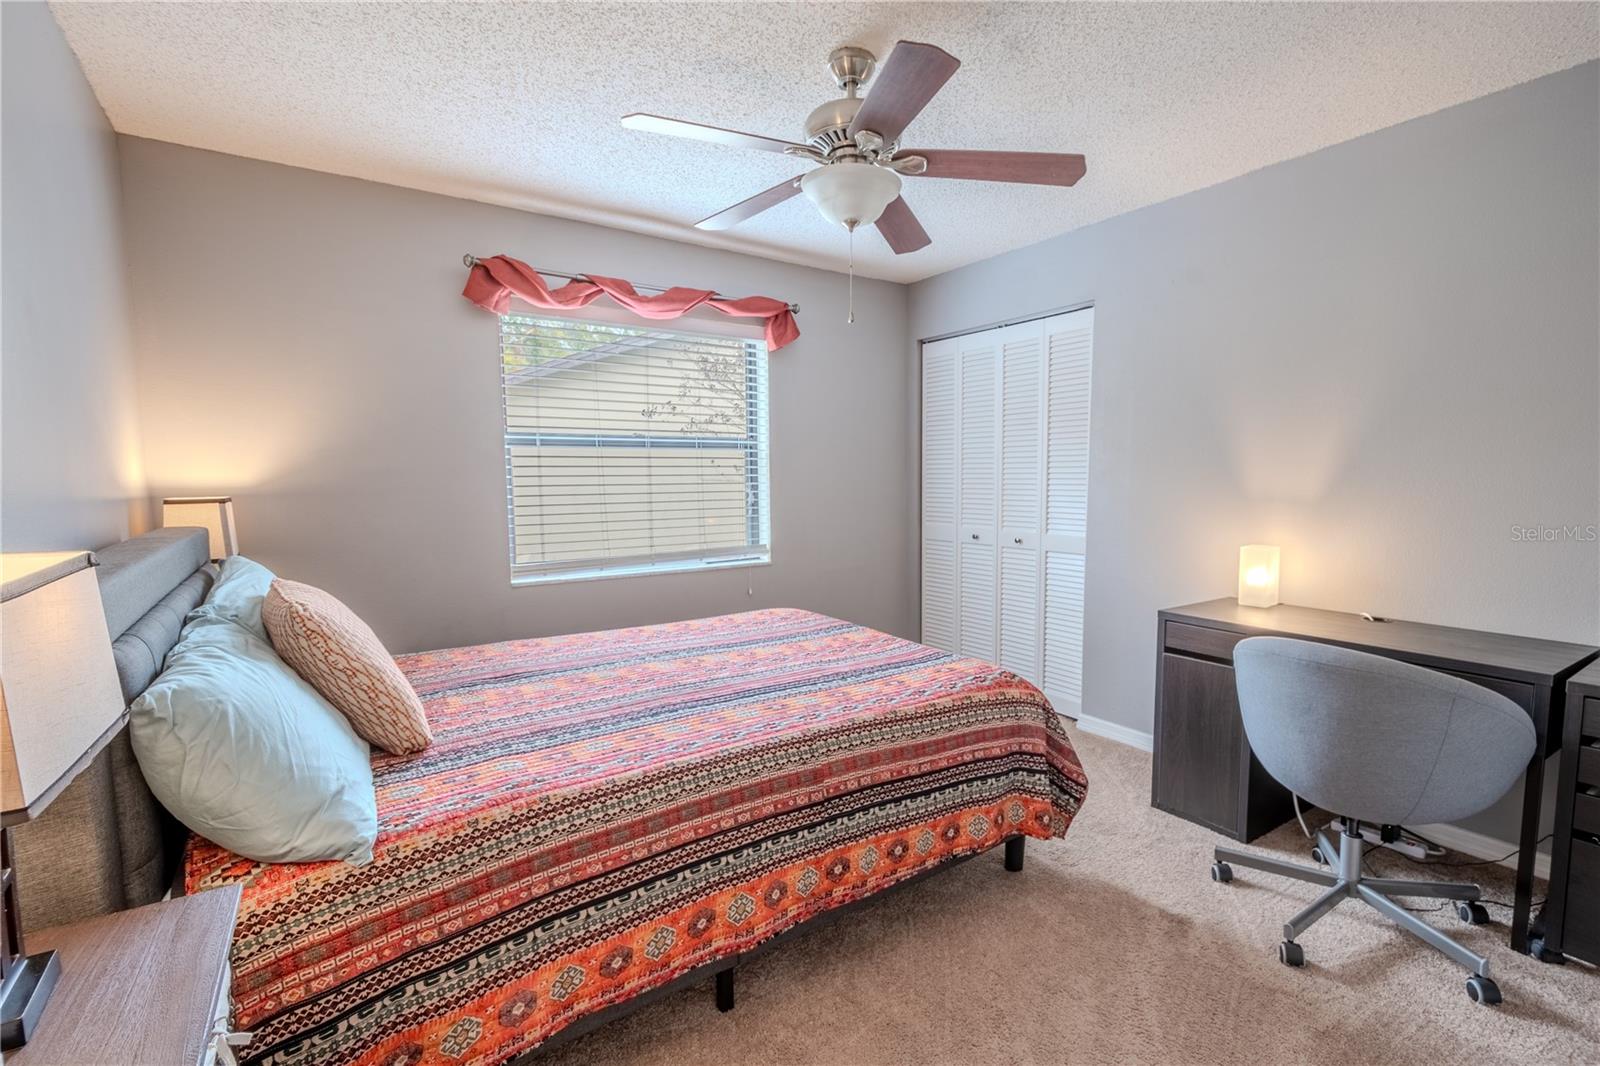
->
[546,731,1600,1066]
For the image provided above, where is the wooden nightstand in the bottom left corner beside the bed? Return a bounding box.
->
[6,885,240,1066]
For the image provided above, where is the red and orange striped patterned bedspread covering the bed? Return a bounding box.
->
[186,610,1086,1066]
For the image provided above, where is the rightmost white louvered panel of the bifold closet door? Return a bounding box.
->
[1042,307,1094,717]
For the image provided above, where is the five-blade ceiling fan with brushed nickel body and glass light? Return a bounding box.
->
[622,40,1083,254]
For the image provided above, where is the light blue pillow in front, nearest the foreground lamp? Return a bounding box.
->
[130,601,378,863]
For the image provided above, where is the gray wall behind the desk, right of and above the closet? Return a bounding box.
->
[910,62,1600,839]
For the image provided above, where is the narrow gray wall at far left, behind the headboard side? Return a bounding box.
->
[0,3,144,552]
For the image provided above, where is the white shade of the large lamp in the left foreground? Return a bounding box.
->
[0,552,126,823]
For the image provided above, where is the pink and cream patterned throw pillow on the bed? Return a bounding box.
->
[261,578,434,755]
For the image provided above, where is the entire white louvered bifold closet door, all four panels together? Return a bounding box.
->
[922,309,1094,717]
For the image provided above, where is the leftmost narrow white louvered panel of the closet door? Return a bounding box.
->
[922,338,962,653]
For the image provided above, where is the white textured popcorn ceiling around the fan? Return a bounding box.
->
[53,2,1600,282]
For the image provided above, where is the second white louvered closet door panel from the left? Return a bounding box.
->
[957,330,1000,663]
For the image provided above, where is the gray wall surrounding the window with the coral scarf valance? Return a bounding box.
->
[120,138,915,651]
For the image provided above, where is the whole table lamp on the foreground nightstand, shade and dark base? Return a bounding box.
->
[0,552,128,1050]
